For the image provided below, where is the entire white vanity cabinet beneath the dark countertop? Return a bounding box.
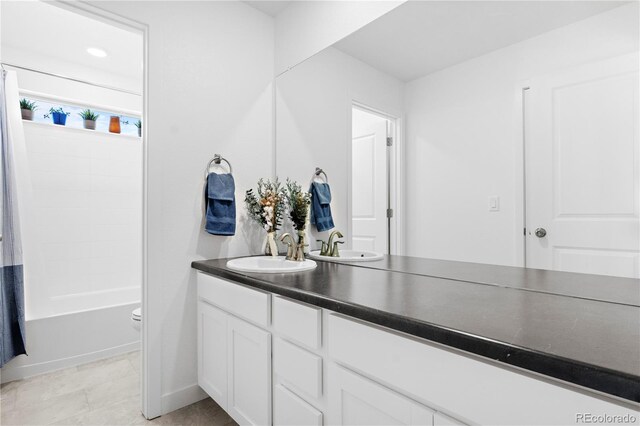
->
[198,273,640,426]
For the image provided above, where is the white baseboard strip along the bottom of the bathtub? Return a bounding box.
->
[0,342,140,383]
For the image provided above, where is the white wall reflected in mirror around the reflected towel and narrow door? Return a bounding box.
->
[276,48,403,248]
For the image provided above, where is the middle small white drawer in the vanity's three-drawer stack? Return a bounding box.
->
[273,339,322,399]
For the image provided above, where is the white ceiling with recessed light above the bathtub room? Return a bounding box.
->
[0,0,143,87]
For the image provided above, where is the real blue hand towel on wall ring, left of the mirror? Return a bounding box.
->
[205,173,236,235]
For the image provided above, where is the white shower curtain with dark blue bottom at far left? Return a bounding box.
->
[0,70,27,367]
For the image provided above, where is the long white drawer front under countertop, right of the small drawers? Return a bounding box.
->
[326,314,637,425]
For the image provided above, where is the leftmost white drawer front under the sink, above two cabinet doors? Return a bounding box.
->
[198,272,270,327]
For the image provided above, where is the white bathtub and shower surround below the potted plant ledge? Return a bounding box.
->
[2,122,142,382]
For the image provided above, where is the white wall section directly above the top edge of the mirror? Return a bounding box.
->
[275,0,406,75]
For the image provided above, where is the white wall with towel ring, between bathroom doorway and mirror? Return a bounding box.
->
[92,1,274,412]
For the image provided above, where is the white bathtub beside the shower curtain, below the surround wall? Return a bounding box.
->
[0,302,140,383]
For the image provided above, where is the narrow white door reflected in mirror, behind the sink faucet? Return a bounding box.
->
[351,108,389,253]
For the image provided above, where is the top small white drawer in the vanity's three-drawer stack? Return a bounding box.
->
[273,296,322,349]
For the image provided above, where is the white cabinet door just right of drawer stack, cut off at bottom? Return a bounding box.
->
[328,365,433,426]
